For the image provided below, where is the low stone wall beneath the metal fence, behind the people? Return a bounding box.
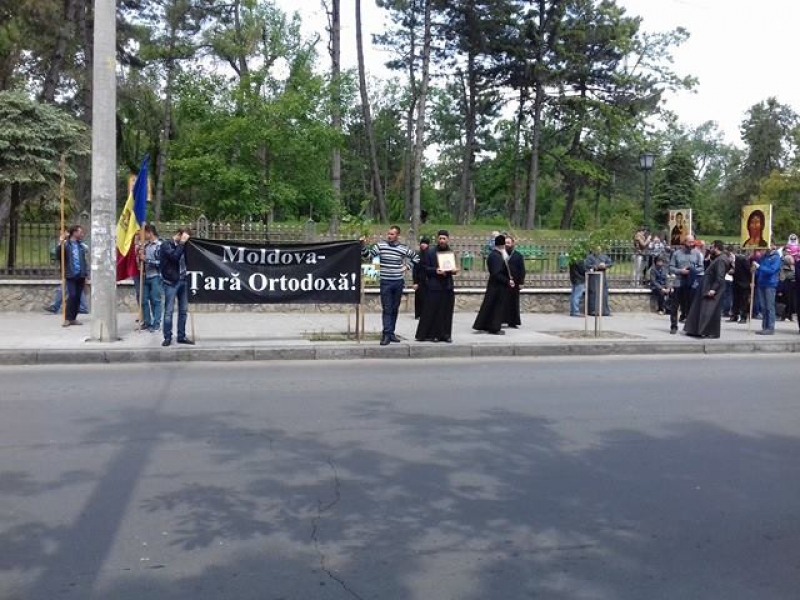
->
[0,280,652,313]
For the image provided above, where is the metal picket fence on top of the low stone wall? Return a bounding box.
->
[0,214,634,288]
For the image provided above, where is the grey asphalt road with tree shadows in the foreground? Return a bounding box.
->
[0,355,800,600]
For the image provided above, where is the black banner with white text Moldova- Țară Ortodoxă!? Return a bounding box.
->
[186,239,361,304]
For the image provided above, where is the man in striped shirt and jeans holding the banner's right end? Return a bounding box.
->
[361,225,419,346]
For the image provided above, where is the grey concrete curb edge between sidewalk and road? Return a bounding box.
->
[0,340,800,366]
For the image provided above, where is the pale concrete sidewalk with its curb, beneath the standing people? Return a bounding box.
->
[0,313,800,365]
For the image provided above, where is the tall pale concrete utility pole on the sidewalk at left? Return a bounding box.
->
[91,0,117,342]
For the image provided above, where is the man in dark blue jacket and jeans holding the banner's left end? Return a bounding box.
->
[159,228,194,346]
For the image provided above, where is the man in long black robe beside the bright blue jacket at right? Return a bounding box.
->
[683,240,731,338]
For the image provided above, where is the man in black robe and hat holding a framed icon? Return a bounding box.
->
[414,229,458,344]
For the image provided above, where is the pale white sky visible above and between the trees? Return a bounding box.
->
[276,0,800,144]
